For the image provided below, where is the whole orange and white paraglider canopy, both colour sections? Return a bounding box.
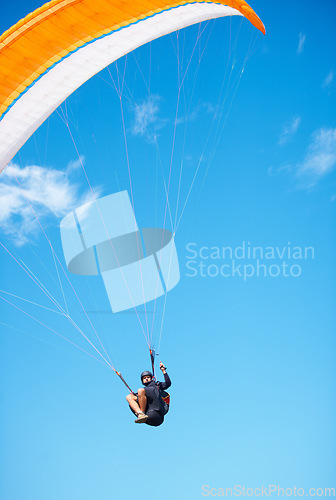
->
[0,0,265,172]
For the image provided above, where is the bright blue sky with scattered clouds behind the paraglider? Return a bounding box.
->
[0,0,336,500]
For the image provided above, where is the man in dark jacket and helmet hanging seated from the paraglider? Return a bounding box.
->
[126,361,171,427]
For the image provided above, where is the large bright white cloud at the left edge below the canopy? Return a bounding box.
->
[0,158,100,246]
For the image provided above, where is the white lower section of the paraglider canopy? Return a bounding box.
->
[0,3,242,172]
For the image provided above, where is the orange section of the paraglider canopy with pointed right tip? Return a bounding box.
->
[0,0,265,118]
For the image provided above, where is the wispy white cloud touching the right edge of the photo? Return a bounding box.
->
[295,128,336,189]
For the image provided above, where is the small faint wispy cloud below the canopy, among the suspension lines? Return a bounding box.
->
[132,95,166,142]
